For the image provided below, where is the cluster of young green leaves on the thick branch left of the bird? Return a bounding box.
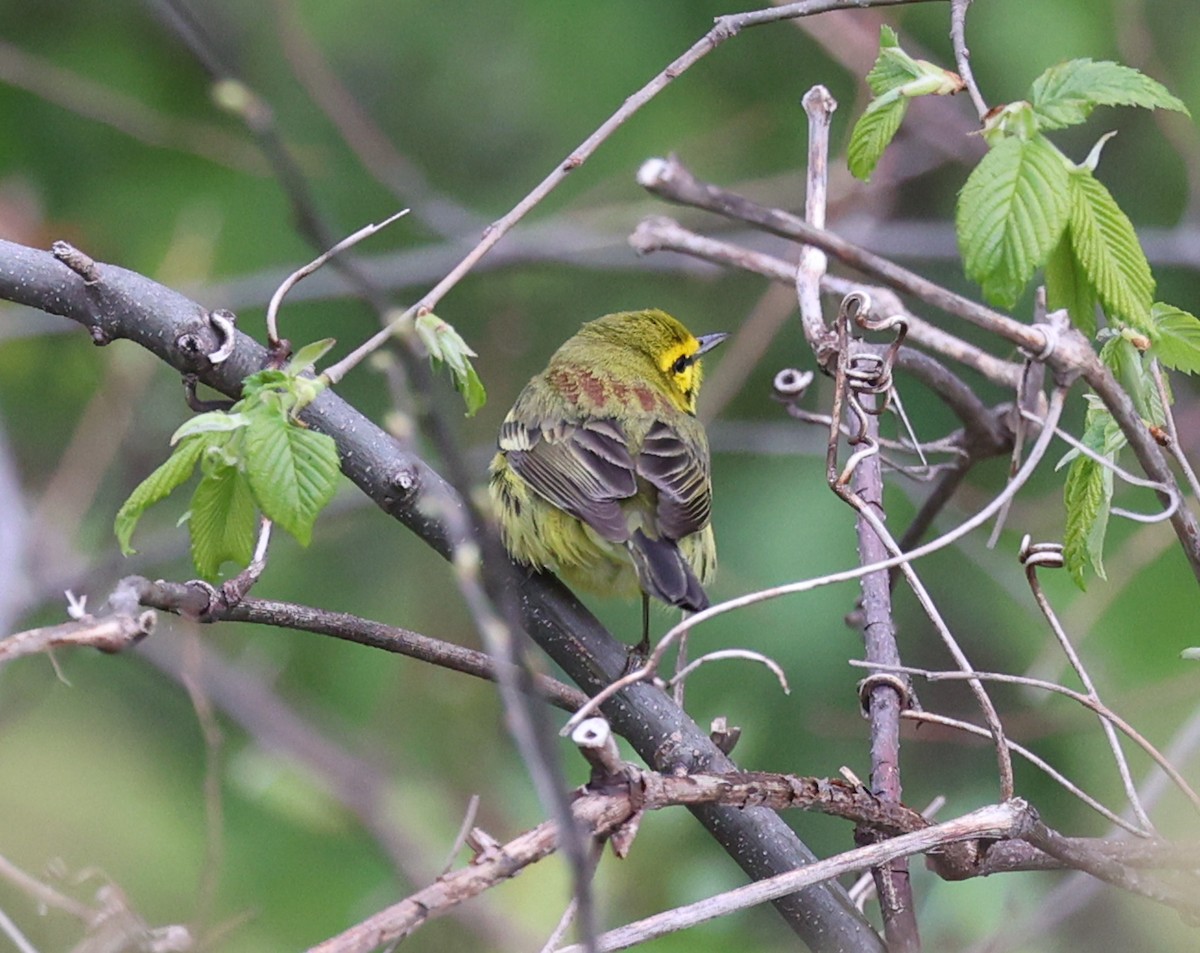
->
[113,341,338,580]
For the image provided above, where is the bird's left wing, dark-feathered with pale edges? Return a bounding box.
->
[500,418,637,543]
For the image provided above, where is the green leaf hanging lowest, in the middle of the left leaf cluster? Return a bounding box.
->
[187,463,258,580]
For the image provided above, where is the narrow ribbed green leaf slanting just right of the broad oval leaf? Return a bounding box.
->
[1068,169,1154,337]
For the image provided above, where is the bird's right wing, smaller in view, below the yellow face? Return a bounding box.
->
[637,420,713,539]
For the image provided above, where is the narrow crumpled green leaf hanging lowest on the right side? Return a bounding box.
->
[1062,406,1124,589]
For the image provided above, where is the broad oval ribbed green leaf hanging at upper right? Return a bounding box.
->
[955,136,1069,307]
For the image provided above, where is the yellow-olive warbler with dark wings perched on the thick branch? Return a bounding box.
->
[490,310,727,654]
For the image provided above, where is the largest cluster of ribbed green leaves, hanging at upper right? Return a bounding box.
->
[955,59,1187,337]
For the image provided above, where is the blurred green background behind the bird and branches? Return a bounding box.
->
[0,0,1200,953]
